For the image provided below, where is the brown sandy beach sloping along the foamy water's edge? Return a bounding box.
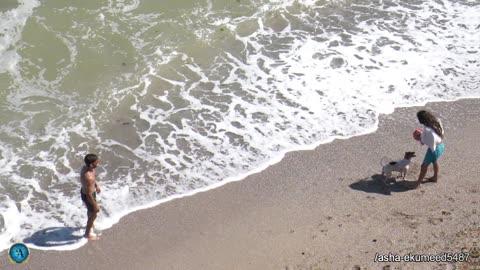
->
[0,99,480,270]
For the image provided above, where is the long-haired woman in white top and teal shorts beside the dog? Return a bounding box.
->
[414,110,445,188]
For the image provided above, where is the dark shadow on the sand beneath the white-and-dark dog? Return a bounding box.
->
[350,174,412,195]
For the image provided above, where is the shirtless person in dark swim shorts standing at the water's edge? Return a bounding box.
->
[80,154,101,240]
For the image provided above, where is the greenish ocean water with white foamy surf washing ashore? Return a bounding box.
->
[0,0,480,250]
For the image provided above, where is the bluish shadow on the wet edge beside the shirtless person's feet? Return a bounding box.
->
[23,227,84,247]
